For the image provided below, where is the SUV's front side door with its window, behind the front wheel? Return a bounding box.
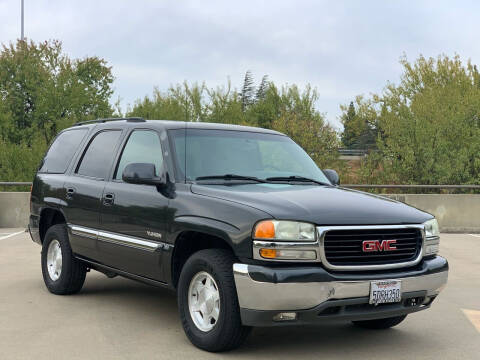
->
[98,129,169,281]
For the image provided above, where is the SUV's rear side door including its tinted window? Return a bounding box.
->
[64,130,122,260]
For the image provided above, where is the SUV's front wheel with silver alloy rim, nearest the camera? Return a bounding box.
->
[177,249,251,352]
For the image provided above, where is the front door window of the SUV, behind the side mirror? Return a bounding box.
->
[115,130,163,180]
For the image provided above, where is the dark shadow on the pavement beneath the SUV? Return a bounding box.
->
[73,274,438,359]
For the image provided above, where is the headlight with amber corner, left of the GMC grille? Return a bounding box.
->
[253,220,315,241]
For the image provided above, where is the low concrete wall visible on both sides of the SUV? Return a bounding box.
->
[0,192,480,233]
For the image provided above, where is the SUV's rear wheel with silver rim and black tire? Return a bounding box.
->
[41,225,87,295]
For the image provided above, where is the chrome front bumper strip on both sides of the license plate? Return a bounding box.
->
[233,263,448,311]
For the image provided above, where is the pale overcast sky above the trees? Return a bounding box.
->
[0,0,480,128]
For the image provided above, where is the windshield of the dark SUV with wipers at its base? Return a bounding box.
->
[170,129,329,183]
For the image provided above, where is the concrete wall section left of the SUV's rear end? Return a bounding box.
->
[0,192,30,228]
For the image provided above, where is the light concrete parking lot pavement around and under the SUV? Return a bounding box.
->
[0,229,480,360]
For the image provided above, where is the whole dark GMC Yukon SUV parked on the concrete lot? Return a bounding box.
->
[29,118,448,351]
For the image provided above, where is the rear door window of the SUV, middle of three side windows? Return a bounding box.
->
[77,130,122,179]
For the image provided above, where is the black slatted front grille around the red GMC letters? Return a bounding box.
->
[324,228,422,266]
